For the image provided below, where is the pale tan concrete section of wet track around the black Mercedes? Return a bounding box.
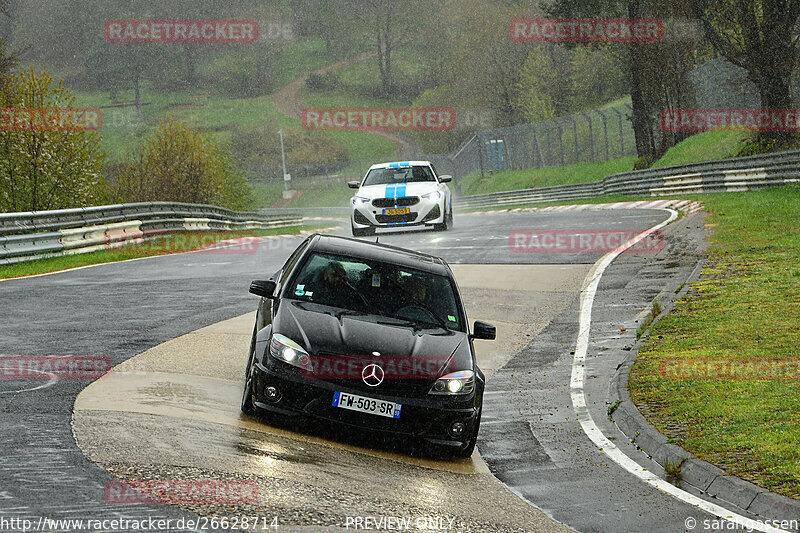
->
[74,265,587,531]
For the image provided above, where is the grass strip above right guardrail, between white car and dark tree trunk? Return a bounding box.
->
[460,156,636,196]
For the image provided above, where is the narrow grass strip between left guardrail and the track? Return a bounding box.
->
[0,224,330,279]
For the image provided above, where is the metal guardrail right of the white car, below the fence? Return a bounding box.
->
[454,150,800,210]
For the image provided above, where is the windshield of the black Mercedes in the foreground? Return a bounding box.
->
[284,249,463,331]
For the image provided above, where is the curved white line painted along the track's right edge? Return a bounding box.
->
[570,209,784,533]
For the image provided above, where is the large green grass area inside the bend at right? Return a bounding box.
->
[630,186,800,498]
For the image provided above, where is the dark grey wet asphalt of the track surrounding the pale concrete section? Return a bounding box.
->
[0,210,732,531]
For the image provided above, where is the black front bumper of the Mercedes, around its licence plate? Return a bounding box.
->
[253,356,482,448]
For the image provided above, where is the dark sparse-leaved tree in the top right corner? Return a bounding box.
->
[690,0,800,140]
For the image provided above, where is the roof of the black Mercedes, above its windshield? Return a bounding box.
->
[309,234,452,277]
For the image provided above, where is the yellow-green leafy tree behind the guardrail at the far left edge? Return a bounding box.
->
[0,69,105,211]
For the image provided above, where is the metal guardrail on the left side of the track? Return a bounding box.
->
[0,202,302,264]
